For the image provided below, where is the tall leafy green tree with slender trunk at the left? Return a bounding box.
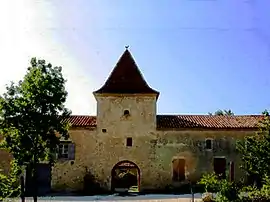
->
[0,58,71,201]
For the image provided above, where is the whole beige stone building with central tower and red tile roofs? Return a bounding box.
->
[1,47,261,194]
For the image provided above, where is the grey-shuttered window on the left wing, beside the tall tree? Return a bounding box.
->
[58,142,75,160]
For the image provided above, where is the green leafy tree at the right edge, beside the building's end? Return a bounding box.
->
[237,111,270,187]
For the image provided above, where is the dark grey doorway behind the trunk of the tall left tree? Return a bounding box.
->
[25,163,51,196]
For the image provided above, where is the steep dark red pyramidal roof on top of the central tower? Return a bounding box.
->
[94,49,159,96]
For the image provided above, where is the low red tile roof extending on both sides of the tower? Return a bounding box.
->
[64,115,263,129]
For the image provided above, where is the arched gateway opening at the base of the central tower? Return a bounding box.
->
[111,161,140,192]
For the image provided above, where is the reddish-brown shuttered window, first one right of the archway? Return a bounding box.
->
[172,159,186,182]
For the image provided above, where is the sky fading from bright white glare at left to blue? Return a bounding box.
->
[0,0,270,115]
